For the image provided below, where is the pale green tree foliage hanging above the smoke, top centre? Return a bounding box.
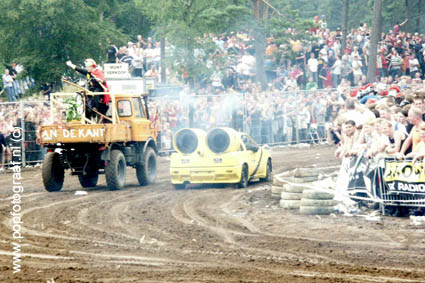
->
[139,0,251,84]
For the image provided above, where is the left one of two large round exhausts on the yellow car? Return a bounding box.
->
[173,129,206,154]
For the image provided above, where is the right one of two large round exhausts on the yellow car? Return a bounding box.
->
[207,128,240,153]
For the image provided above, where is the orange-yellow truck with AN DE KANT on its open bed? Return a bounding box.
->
[39,86,157,192]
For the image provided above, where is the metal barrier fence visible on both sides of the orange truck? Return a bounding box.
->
[0,90,338,168]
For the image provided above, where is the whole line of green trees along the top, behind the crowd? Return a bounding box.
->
[0,0,425,91]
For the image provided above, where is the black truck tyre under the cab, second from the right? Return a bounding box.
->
[105,149,127,190]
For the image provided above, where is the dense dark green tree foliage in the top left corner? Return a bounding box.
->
[0,0,129,86]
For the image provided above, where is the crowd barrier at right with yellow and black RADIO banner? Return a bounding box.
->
[339,154,425,214]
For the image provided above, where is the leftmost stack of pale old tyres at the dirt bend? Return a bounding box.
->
[279,168,319,209]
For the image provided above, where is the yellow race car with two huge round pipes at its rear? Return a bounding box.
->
[170,128,272,189]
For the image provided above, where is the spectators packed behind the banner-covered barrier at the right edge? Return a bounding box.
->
[332,84,425,216]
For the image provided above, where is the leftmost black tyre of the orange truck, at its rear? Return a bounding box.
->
[42,152,65,192]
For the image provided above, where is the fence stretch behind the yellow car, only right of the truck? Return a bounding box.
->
[150,89,337,151]
